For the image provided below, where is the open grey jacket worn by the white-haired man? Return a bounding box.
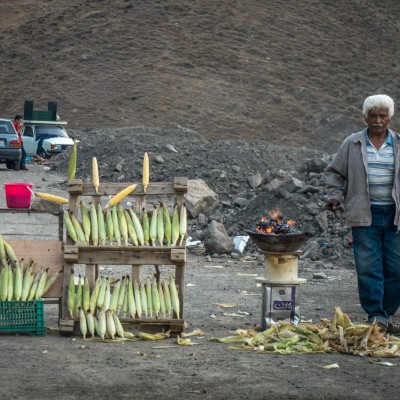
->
[325,129,400,229]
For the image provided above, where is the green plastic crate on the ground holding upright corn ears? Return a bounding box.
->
[0,300,46,336]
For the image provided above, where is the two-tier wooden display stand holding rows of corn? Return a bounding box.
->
[60,177,187,335]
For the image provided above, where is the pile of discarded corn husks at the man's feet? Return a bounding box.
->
[210,307,400,358]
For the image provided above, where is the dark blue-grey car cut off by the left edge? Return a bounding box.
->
[0,118,22,171]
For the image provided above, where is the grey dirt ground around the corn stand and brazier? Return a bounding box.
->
[0,164,398,400]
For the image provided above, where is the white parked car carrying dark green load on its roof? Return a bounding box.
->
[21,121,74,158]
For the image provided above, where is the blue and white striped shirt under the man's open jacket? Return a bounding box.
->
[365,133,394,205]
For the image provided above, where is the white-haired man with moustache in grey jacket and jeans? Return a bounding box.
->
[325,95,400,334]
